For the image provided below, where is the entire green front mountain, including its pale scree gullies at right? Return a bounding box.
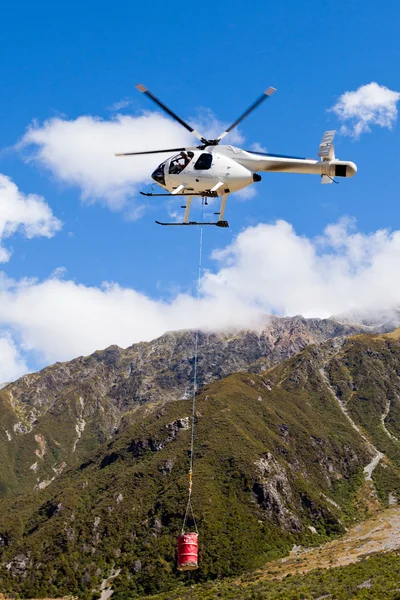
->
[0,331,400,600]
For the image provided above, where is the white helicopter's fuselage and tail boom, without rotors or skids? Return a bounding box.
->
[152,145,357,196]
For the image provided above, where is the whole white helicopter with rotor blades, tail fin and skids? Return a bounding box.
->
[115,84,357,227]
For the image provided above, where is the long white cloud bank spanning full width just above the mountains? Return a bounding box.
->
[0,219,400,370]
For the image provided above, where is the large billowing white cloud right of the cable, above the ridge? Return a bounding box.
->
[207,219,400,317]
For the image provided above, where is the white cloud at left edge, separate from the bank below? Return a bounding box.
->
[0,174,61,262]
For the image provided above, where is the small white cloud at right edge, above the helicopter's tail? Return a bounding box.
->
[330,81,400,138]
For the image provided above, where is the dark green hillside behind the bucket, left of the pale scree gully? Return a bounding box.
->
[0,357,368,599]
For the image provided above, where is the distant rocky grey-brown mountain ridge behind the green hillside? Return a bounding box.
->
[0,317,363,497]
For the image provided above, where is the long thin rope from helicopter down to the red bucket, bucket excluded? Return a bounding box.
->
[182,198,204,533]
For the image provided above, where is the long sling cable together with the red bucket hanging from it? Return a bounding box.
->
[178,204,204,571]
